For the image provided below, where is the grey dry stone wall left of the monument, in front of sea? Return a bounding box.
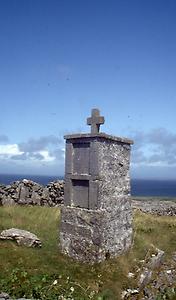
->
[0,179,64,206]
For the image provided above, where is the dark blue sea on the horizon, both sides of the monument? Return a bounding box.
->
[0,174,176,197]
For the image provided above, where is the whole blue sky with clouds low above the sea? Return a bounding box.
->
[0,0,176,179]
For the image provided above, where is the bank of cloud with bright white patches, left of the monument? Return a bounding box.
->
[0,135,64,175]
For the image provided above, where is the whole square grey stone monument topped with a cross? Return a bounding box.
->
[60,109,133,263]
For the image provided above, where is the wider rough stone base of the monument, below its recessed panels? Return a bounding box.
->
[60,199,132,262]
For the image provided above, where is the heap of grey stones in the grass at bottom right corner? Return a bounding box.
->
[121,248,176,300]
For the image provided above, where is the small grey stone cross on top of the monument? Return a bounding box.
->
[87,108,105,134]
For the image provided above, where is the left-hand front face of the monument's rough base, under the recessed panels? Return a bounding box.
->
[60,206,105,263]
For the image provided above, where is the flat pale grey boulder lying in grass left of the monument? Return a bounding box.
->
[0,228,41,247]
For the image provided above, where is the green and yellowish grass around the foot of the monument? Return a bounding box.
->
[0,206,176,300]
